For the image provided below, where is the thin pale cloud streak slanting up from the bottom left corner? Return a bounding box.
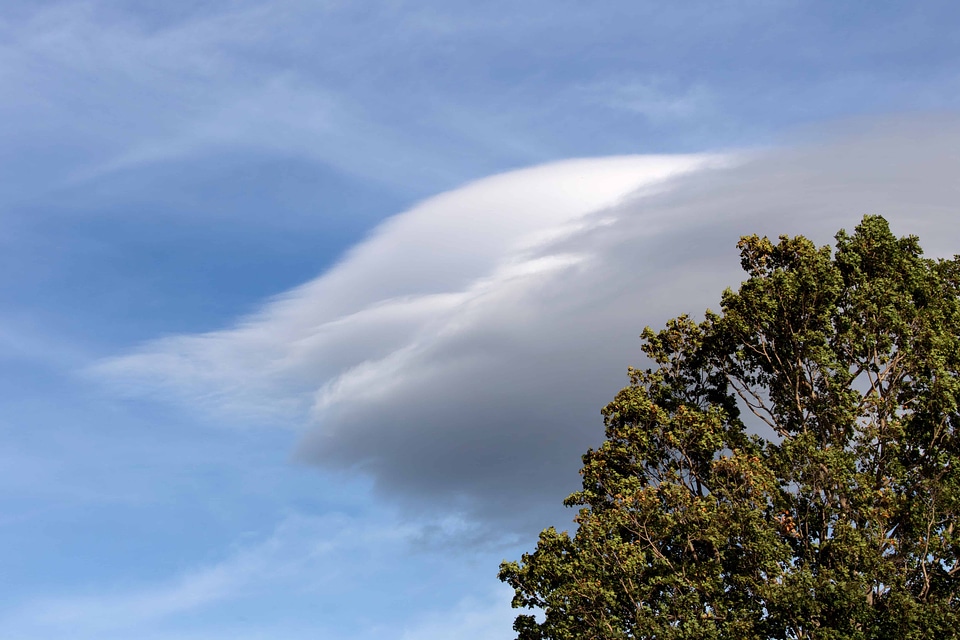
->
[0,514,472,639]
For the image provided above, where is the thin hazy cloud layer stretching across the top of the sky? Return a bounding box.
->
[7,0,960,210]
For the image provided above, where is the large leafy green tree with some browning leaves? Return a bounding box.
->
[500,216,960,640]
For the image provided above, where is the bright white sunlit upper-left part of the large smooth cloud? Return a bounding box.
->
[97,157,706,420]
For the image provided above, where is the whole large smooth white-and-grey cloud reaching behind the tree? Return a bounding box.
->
[97,120,960,526]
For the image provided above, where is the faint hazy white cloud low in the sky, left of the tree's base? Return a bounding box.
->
[0,513,513,640]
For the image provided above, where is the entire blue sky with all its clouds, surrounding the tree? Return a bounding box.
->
[0,0,960,640]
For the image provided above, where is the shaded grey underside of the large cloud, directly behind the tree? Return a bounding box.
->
[99,118,960,529]
